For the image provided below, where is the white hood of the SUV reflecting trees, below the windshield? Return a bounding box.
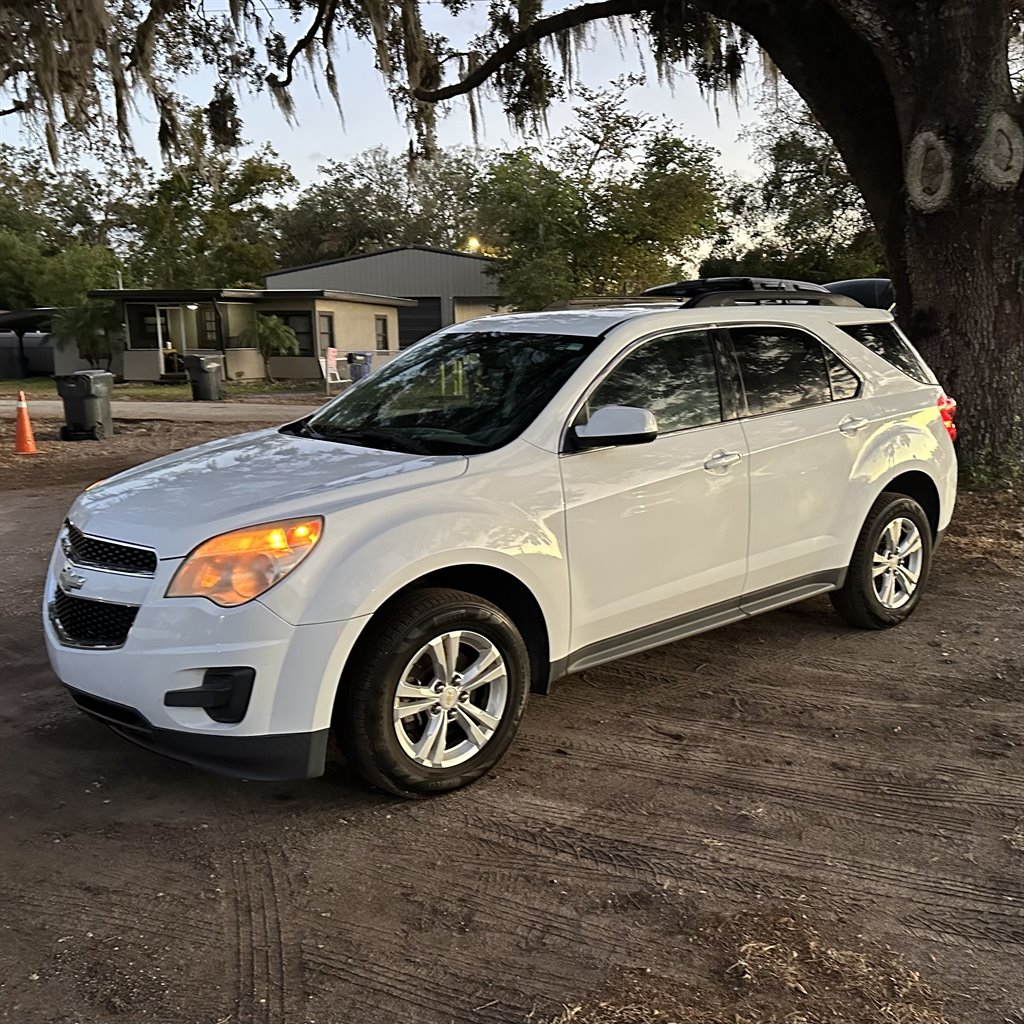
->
[69,428,467,558]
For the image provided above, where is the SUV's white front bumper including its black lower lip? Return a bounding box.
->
[43,532,366,779]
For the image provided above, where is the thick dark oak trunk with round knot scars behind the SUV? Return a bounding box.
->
[724,0,1024,483]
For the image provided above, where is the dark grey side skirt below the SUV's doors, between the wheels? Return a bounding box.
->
[549,567,847,683]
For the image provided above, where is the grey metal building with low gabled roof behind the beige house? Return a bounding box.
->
[266,246,501,348]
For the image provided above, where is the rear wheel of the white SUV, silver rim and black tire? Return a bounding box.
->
[828,490,932,630]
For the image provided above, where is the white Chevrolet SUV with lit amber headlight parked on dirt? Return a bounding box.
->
[44,292,956,797]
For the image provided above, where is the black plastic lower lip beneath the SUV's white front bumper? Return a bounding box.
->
[66,684,330,781]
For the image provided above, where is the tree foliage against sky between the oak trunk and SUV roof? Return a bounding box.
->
[700,91,888,282]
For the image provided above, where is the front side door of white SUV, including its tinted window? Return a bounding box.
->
[560,330,749,651]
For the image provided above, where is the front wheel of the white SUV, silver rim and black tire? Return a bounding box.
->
[335,589,529,797]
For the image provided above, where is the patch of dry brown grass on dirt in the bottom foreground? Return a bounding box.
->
[549,918,948,1024]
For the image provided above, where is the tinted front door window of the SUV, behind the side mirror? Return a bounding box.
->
[588,331,722,433]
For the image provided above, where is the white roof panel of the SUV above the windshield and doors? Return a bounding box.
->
[445,302,892,338]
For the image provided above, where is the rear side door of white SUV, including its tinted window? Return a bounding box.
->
[727,325,876,595]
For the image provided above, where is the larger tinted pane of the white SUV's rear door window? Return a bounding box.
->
[729,327,831,416]
